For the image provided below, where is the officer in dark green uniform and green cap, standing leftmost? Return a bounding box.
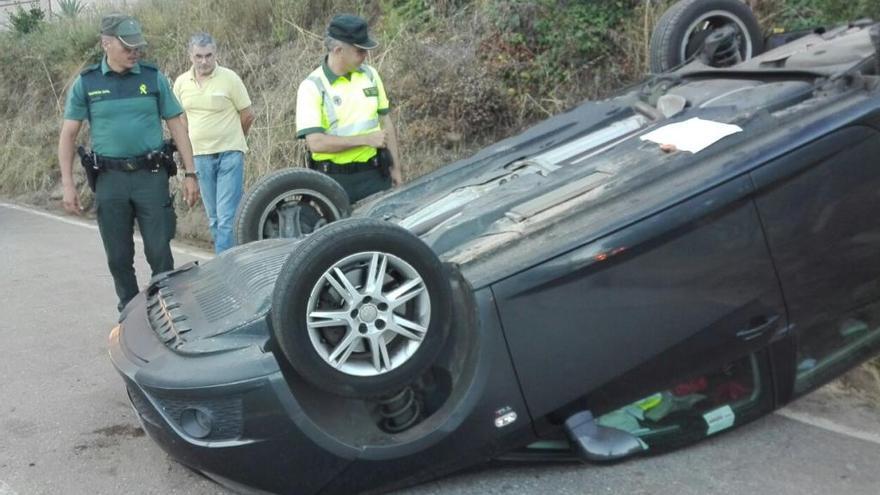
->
[58,14,199,311]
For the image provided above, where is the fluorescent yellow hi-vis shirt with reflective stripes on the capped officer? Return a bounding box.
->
[296,59,389,165]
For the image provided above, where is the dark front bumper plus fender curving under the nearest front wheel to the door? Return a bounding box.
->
[110,280,534,495]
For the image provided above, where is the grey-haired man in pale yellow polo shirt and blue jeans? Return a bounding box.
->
[174,33,255,253]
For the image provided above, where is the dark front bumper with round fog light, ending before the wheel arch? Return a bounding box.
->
[110,294,354,493]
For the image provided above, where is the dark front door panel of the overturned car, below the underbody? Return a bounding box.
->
[493,176,786,419]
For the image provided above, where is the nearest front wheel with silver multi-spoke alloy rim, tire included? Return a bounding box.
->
[271,218,452,398]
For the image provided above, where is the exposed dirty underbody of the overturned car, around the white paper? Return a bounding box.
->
[355,21,877,286]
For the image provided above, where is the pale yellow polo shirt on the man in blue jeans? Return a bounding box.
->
[174,65,251,155]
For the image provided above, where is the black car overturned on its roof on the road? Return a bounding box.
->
[110,0,880,494]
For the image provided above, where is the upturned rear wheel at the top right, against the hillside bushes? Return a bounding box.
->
[650,0,764,74]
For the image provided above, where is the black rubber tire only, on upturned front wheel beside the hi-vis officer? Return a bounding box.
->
[232,167,351,245]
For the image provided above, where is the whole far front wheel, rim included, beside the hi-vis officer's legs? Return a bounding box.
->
[233,168,351,244]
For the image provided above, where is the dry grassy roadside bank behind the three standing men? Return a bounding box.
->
[0,0,654,219]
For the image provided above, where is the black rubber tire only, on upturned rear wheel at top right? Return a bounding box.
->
[649,0,764,74]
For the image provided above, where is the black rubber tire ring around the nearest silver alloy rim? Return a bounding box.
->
[270,218,452,399]
